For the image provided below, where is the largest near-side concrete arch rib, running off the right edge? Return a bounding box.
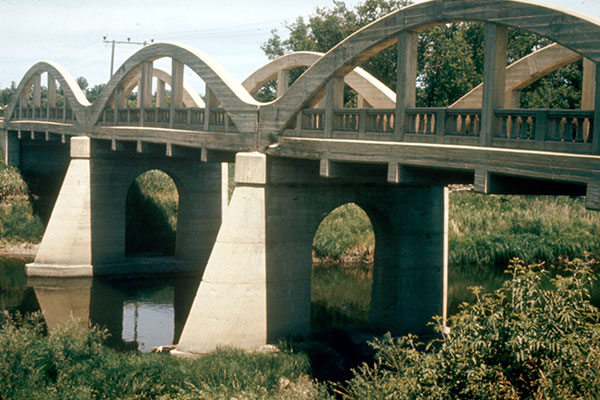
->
[261,0,600,134]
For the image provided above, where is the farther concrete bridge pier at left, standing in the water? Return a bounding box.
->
[27,137,222,276]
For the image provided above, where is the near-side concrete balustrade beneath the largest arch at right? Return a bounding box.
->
[286,107,594,153]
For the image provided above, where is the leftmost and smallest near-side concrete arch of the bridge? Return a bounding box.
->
[4,61,91,123]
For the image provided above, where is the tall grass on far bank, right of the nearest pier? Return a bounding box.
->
[449,191,600,266]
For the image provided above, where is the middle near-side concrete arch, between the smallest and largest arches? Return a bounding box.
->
[88,43,261,132]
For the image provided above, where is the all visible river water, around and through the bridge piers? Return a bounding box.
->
[0,257,600,352]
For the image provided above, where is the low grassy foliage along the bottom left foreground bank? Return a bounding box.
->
[0,314,316,400]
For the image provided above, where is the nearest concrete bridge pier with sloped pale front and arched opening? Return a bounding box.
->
[176,153,447,354]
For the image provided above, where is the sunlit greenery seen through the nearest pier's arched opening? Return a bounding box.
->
[313,203,374,260]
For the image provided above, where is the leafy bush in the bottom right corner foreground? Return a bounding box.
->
[342,260,600,400]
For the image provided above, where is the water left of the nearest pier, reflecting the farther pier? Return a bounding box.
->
[0,258,200,351]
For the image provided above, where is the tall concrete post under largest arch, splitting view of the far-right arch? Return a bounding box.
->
[479,22,508,146]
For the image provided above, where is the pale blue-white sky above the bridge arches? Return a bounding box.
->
[0,0,600,91]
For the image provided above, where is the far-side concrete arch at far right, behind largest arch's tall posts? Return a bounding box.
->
[449,43,581,108]
